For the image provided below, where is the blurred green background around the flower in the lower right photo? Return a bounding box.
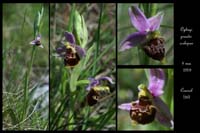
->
[117,69,174,130]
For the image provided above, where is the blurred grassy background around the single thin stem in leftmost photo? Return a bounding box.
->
[2,4,49,130]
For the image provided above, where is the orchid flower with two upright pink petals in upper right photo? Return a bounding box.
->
[120,6,165,61]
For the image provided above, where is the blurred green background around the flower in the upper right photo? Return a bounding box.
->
[117,3,174,65]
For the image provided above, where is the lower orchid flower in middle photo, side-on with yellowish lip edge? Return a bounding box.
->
[86,77,114,106]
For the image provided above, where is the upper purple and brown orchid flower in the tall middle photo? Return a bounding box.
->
[56,32,86,67]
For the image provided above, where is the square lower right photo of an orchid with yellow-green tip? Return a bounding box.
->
[117,68,174,131]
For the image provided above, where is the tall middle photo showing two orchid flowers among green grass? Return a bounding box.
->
[49,3,116,131]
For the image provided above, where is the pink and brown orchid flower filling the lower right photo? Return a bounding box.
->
[118,69,174,128]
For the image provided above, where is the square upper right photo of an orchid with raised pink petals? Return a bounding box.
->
[117,3,174,65]
